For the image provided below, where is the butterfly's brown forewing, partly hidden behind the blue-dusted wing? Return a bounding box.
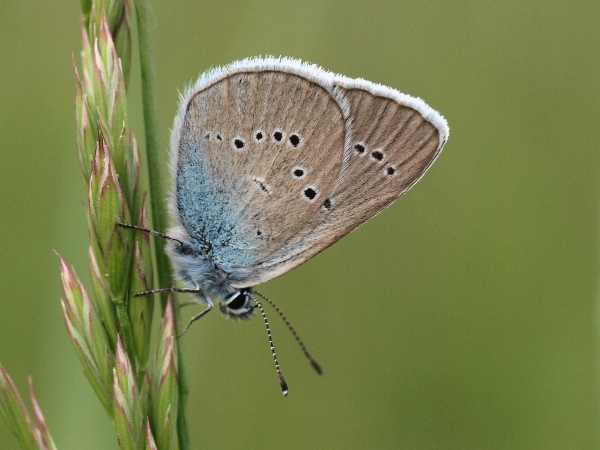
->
[236,73,448,284]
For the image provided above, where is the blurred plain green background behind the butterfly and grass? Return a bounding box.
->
[0,0,600,449]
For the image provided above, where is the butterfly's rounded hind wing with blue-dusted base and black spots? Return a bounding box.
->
[172,60,348,285]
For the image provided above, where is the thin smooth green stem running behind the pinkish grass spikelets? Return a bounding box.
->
[135,0,190,450]
